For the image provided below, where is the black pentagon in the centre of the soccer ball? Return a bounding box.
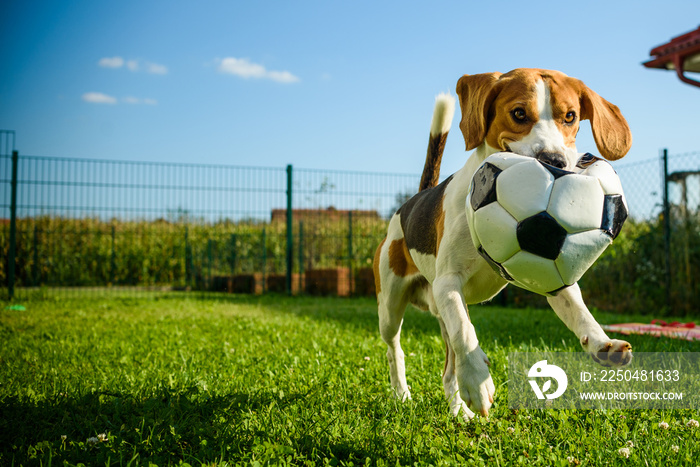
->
[516,211,566,260]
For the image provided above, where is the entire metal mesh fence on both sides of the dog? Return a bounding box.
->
[0,135,700,311]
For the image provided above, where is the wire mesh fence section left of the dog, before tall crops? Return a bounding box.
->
[0,155,418,302]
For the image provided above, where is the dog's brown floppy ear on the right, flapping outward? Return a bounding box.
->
[581,84,632,161]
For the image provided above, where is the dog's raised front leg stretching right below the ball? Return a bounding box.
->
[547,284,632,366]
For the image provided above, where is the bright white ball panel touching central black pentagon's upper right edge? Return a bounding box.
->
[547,174,605,233]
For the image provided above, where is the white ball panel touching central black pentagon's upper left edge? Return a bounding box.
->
[496,158,552,221]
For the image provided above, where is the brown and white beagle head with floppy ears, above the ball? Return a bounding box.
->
[457,68,632,169]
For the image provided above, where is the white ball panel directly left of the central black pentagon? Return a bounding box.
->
[472,203,520,263]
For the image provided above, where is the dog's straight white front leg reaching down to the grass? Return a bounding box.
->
[433,274,496,416]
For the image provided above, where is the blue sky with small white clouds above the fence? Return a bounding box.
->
[0,0,700,175]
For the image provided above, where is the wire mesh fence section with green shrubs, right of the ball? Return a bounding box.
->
[581,151,700,315]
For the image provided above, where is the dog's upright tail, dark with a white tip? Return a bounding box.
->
[418,93,455,191]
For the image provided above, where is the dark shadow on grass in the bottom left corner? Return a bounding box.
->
[0,384,411,465]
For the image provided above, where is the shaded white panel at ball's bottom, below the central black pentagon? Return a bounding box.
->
[502,251,564,294]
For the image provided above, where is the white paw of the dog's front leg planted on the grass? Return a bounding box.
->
[457,347,496,419]
